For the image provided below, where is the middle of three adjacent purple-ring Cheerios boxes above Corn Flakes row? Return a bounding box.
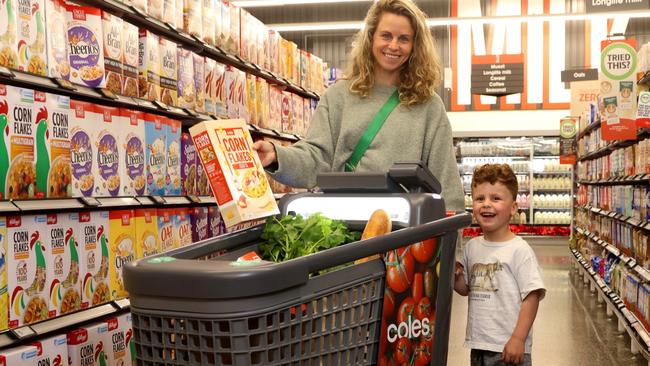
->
[95,105,123,197]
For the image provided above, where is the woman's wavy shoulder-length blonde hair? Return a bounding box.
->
[347,0,442,106]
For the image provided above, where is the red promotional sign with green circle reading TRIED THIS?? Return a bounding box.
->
[599,39,637,140]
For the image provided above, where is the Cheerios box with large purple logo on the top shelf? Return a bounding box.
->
[66,2,106,88]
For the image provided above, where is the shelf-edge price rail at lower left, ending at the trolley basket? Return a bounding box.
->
[0,299,130,349]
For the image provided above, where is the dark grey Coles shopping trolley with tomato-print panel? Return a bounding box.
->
[123,163,471,365]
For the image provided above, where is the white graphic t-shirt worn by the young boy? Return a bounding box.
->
[462,236,546,353]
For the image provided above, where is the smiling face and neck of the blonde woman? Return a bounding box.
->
[372,13,414,85]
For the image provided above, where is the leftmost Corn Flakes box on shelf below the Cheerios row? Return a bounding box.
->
[5,215,50,328]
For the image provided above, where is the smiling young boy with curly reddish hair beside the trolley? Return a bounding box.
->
[454,164,546,366]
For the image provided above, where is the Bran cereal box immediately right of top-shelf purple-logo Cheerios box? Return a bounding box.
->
[102,10,124,94]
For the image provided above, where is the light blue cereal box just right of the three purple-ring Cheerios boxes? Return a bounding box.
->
[144,113,167,196]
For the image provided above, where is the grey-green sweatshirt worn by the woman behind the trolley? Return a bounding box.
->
[272,80,465,211]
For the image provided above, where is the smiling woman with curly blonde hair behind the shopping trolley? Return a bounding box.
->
[254,0,464,211]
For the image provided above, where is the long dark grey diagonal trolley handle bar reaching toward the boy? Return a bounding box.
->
[292,212,472,273]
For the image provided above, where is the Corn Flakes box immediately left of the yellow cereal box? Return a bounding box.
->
[77,211,111,309]
